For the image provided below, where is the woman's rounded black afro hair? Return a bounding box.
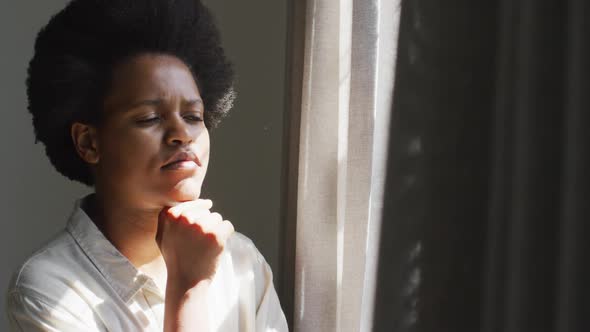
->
[27,0,235,186]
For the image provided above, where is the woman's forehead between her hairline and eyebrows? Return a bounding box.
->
[105,54,200,104]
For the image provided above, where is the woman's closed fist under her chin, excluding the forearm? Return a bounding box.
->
[156,199,234,289]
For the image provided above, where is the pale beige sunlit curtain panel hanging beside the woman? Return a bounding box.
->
[293,0,399,331]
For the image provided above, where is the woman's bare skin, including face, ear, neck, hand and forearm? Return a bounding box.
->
[72,54,233,331]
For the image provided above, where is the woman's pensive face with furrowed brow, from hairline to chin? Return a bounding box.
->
[95,54,209,208]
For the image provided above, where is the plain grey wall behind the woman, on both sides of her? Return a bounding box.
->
[0,0,287,330]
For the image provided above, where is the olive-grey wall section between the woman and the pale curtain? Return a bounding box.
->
[204,0,287,284]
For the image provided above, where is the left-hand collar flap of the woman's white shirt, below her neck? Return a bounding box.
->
[66,194,162,303]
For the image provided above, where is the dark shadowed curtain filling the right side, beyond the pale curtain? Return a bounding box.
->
[374,0,590,332]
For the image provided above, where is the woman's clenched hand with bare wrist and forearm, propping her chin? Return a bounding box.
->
[156,199,234,332]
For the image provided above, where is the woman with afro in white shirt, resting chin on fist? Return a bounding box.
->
[7,0,287,331]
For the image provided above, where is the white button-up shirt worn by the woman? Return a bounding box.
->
[6,199,288,332]
